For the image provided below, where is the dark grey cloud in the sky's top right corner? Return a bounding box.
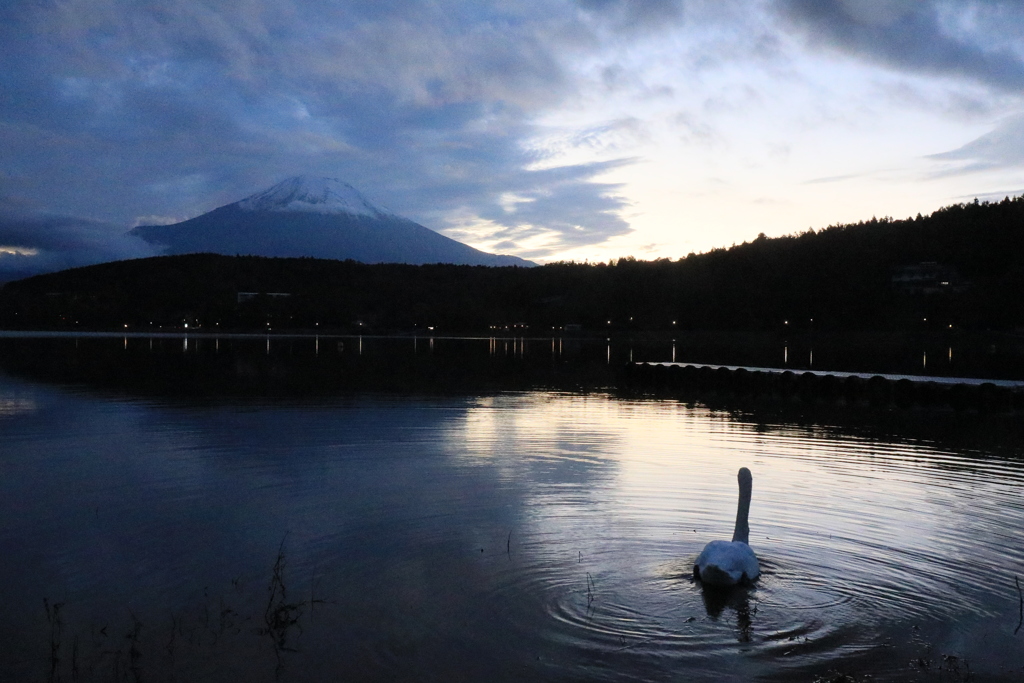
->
[776,0,1024,91]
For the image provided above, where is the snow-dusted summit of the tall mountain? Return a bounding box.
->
[239,175,392,218]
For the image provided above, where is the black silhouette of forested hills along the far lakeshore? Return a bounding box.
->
[0,197,1024,334]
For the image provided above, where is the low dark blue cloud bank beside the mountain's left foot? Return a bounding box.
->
[0,213,156,282]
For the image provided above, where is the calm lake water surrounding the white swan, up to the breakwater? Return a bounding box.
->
[0,337,1024,681]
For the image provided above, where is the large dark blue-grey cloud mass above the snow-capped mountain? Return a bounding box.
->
[0,0,643,266]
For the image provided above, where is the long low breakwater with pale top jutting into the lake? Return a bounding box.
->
[626,362,1024,412]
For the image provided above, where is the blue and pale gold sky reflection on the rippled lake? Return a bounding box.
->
[0,379,1024,680]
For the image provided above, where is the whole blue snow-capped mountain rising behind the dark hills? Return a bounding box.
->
[130,176,534,266]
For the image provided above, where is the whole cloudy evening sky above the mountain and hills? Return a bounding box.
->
[0,0,1024,275]
